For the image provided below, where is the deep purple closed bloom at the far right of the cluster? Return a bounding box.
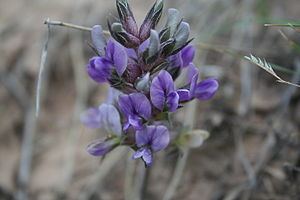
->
[193,78,219,100]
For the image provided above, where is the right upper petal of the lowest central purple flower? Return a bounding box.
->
[151,125,170,152]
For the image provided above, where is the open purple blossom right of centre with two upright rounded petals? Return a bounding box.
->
[150,70,179,112]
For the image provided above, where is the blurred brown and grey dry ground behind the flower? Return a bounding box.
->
[0,0,300,200]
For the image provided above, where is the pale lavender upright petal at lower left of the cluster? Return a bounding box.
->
[99,104,122,135]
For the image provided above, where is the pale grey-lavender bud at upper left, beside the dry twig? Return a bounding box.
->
[91,25,106,56]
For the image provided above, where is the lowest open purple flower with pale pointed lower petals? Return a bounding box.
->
[133,125,170,166]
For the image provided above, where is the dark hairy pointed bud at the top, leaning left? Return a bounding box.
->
[116,0,139,37]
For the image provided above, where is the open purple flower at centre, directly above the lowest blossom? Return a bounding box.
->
[119,93,151,130]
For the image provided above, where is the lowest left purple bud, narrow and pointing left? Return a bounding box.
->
[87,139,118,156]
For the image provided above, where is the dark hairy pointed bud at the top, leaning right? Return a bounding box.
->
[139,0,163,41]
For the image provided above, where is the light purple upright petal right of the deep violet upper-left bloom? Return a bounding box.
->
[106,39,128,76]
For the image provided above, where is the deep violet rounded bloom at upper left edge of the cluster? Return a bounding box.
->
[87,57,112,83]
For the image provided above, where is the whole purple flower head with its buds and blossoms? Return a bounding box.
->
[81,0,218,166]
